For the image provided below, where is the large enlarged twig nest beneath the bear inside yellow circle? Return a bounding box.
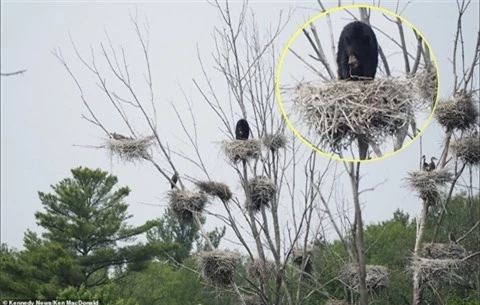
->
[293,73,436,151]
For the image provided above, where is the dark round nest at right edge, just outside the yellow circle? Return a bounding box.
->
[435,92,478,131]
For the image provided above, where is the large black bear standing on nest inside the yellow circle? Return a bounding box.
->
[337,21,378,80]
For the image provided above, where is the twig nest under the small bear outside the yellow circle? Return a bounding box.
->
[222,139,261,163]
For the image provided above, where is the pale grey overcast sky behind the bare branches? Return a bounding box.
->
[1,1,479,252]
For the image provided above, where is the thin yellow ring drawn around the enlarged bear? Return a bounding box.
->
[275,4,440,163]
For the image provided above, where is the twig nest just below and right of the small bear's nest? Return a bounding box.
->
[246,177,277,212]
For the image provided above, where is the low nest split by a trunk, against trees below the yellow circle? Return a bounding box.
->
[340,264,389,292]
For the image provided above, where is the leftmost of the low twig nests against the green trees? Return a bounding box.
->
[198,250,238,286]
